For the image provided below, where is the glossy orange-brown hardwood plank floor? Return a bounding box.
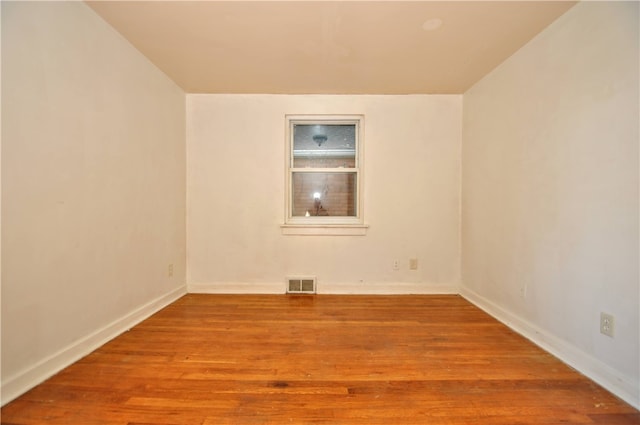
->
[1,294,640,425]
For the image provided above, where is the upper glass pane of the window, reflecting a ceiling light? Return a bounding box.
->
[293,124,356,168]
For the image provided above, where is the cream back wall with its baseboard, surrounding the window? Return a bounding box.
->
[187,95,462,293]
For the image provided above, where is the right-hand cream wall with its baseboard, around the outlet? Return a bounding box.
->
[462,2,640,406]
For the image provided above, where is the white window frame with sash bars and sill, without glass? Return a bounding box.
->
[281,115,368,236]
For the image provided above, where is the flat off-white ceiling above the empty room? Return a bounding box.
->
[87,0,575,94]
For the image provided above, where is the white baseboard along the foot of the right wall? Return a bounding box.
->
[460,287,640,409]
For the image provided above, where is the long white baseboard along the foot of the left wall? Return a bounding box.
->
[1,285,187,406]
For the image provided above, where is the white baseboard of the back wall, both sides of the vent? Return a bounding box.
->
[187,280,458,295]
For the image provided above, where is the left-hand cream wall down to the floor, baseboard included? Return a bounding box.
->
[2,2,186,403]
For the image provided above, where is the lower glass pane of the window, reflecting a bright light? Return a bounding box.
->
[292,173,357,217]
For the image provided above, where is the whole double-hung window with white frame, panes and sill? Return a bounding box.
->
[283,115,366,235]
